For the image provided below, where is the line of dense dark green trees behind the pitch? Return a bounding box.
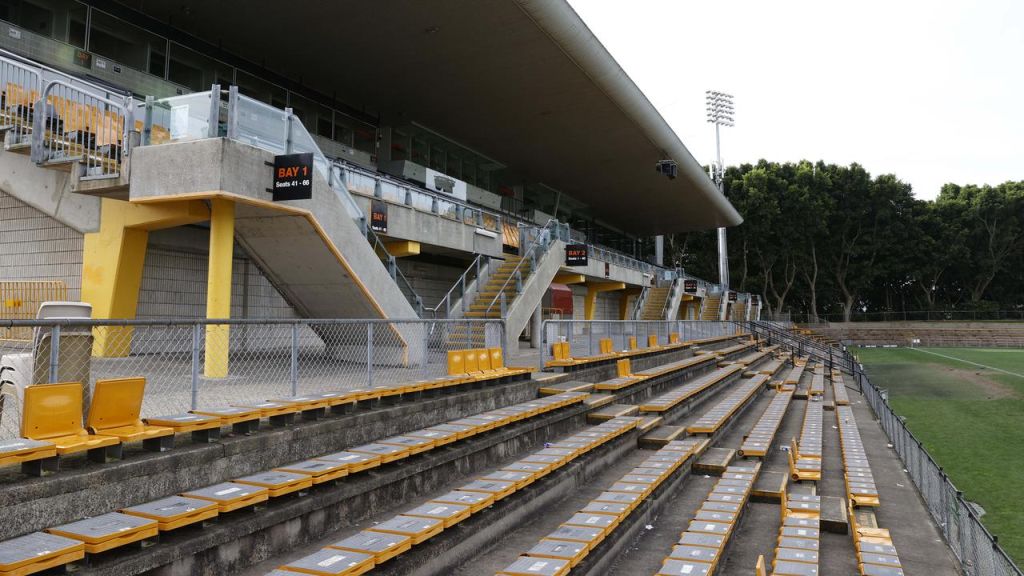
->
[668,160,1024,321]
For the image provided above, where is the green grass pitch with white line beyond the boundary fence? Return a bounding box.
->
[854,348,1024,564]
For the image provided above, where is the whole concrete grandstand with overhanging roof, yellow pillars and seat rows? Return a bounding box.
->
[0,0,1019,576]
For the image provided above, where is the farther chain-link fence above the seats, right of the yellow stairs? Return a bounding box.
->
[541,320,743,366]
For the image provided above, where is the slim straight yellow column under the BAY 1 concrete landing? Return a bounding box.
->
[203,199,234,378]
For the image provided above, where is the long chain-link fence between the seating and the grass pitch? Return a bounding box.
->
[770,324,1024,576]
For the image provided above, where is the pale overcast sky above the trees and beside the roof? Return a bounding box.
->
[569,0,1024,199]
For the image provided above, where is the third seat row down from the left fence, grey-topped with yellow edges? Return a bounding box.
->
[271,412,639,576]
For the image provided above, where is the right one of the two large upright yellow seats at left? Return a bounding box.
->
[85,377,174,451]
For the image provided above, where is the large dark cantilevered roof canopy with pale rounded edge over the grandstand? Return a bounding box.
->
[112,0,741,236]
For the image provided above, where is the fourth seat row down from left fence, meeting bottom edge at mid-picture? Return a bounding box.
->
[498,439,709,576]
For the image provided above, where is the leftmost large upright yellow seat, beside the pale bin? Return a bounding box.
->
[22,382,121,458]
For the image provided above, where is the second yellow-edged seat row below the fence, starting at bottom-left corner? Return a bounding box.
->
[0,386,585,576]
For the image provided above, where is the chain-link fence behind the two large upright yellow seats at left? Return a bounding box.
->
[0,320,508,439]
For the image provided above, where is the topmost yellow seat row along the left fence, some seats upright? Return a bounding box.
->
[0,347,529,476]
